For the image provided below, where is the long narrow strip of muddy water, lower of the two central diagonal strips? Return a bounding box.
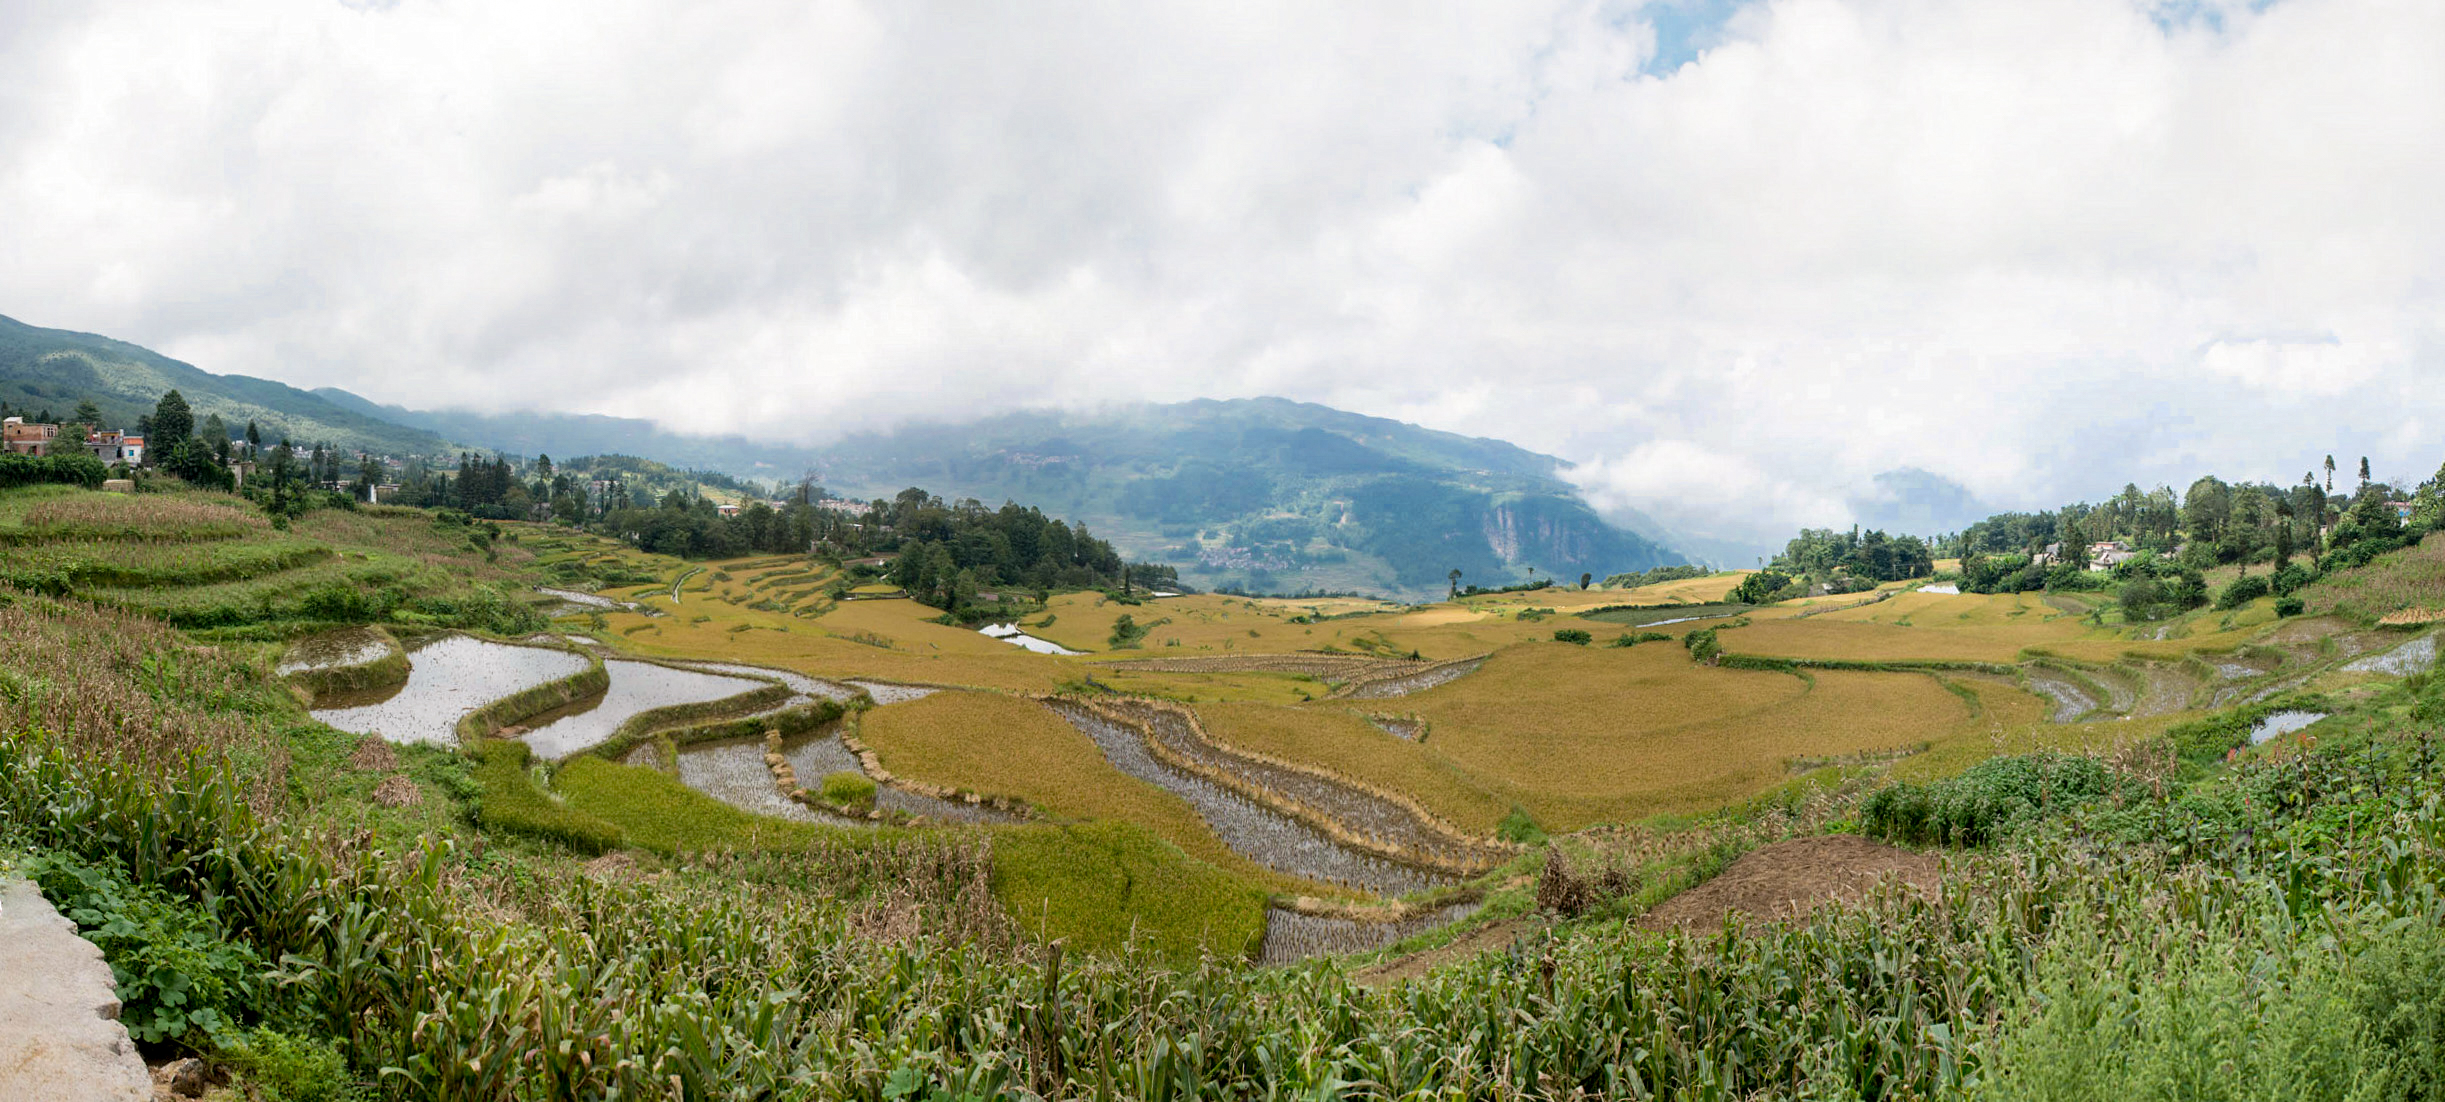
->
[1049,701,1450,894]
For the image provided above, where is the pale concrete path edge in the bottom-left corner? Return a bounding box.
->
[0,880,152,1102]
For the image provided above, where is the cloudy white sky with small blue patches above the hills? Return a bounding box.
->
[0,0,2445,552]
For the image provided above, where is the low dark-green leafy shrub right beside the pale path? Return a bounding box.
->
[24,855,264,1048]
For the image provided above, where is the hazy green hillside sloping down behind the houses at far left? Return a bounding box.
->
[0,318,457,454]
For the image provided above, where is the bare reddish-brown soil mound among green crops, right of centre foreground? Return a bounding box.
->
[1638,833,1944,933]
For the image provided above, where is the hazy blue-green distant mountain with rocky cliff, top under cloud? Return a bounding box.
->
[817,398,1682,596]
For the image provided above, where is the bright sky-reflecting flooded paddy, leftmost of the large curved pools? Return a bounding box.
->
[313,635,587,745]
